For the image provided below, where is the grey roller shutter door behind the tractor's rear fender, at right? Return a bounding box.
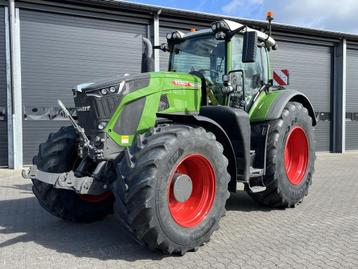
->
[270,42,332,151]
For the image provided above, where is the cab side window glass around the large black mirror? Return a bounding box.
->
[231,34,268,104]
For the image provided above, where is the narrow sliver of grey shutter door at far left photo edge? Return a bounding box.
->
[0,7,8,166]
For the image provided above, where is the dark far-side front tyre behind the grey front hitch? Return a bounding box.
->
[32,126,114,222]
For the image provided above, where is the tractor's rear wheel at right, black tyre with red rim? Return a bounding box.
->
[248,102,316,208]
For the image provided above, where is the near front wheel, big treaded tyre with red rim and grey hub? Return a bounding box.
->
[113,125,230,254]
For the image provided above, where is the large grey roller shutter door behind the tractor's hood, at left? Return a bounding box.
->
[20,10,147,164]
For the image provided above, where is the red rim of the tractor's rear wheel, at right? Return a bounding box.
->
[285,126,308,185]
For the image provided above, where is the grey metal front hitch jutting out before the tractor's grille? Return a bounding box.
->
[22,162,108,195]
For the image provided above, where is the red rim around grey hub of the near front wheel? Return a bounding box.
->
[168,154,216,228]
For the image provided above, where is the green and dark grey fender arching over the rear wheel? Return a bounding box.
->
[249,89,317,126]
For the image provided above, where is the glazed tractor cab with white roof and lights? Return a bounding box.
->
[160,20,276,112]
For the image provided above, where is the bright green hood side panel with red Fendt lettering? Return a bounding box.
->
[105,72,201,146]
